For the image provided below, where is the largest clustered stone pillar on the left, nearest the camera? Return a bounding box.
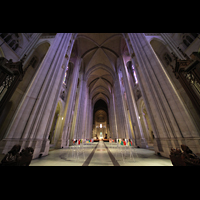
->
[0,33,72,158]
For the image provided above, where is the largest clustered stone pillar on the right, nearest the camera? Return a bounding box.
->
[128,33,199,157]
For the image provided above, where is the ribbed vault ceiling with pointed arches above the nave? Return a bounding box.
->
[76,33,124,105]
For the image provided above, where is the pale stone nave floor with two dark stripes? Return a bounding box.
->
[30,141,172,166]
